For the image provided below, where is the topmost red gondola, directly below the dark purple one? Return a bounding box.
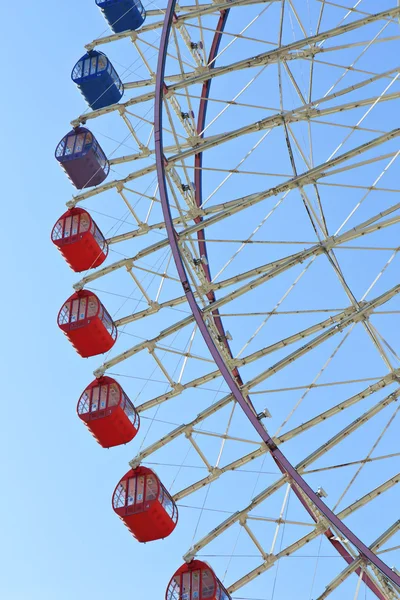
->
[51,208,108,273]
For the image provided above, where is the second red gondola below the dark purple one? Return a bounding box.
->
[58,290,117,358]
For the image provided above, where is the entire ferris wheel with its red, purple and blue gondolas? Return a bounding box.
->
[52,0,400,600]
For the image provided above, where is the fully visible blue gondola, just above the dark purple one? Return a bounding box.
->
[71,50,124,109]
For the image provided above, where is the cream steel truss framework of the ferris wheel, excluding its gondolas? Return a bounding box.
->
[59,0,400,600]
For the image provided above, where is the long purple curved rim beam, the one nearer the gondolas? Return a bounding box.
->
[154,0,400,600]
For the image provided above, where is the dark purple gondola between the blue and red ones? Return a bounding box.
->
[55,127,110,190]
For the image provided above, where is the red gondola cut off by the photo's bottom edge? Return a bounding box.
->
[165,560,231,600]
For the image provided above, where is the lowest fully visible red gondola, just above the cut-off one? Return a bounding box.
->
[112,467,178,542]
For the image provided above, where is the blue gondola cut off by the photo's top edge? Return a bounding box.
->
[96,0,146,33]
